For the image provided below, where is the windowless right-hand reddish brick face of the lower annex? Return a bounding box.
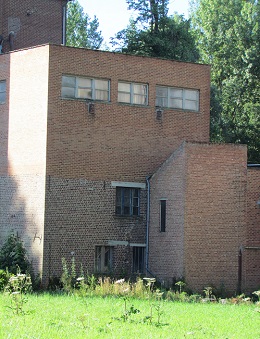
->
[184,143,247,293]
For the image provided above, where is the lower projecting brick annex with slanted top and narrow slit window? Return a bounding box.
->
[149,143,246,292]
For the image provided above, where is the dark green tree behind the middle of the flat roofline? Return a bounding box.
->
[112,0,198,61]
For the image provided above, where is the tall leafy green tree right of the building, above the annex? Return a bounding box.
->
[192,0,260,162]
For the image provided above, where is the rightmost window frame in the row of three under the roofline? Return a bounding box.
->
[156,85,200,112]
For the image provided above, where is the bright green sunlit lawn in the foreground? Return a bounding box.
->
[0,293,260,339]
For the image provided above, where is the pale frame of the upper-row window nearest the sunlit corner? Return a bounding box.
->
[61,74,110,102]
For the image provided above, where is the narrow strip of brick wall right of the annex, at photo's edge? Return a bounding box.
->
[243,167,260,292]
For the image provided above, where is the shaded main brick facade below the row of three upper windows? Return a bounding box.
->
[41,46,209,278]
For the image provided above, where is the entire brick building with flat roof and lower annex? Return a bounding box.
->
[0,0,260,293]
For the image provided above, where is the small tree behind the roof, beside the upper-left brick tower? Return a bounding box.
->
[66,0,103,49]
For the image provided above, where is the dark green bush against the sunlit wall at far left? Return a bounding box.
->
[0,234,30,274]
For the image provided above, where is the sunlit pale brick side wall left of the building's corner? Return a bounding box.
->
[0,46,49,272]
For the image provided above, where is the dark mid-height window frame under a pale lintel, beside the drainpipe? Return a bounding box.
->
[115,186,140,217]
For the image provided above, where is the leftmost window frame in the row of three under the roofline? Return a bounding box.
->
[61,74,111,102]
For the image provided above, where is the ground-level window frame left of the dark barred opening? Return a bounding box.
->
[95,245,114,273]
